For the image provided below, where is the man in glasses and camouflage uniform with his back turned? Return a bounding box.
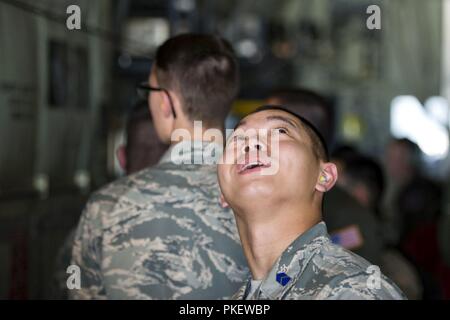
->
[71,34,248,299]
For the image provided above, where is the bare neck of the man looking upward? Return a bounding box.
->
[235,205,321,280]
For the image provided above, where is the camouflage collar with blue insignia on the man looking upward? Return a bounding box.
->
[235,222,330,300]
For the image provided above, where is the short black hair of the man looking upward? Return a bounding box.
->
[247,105,329,162]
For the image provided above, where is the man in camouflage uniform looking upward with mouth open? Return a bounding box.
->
[218,106,404,299]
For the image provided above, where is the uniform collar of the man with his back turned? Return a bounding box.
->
[159,140,223,164]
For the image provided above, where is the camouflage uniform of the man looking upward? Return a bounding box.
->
[233,222,405,300]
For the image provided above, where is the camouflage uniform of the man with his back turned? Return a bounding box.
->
[70,142,249,299]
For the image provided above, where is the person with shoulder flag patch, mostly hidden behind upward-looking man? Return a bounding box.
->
[266,88,383,264]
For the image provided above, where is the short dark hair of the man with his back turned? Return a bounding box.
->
[155,34,239,127]
